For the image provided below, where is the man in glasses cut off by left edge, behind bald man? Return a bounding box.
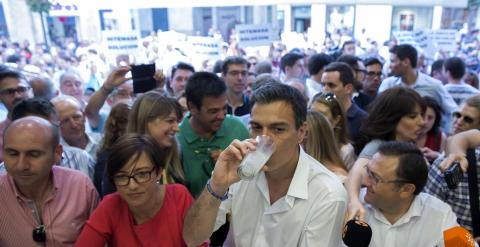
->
[0,69,33,161]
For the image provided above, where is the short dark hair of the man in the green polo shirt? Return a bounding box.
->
[185,72,227,109]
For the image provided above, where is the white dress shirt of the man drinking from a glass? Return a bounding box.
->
[215,148,347,247]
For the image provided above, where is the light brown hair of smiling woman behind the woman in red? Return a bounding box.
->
[127,91,185,183]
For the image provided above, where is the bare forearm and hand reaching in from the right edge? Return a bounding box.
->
[440,129,480,172]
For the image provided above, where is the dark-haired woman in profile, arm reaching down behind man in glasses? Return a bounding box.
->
[345,87,426,223]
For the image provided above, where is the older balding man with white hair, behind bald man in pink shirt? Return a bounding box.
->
[52,95,100,159]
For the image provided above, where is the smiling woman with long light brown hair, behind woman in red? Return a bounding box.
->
[103,91,184,195]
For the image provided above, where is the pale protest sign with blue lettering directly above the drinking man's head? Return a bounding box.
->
[235,25,272,48]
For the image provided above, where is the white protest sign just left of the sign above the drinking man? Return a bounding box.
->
[187,36,221,60]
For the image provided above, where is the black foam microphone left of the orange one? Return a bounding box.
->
[342,219,372,247]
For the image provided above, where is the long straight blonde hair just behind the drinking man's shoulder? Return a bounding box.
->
[304,111,347,171]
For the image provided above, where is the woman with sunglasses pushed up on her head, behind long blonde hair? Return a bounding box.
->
[310,93,356,169]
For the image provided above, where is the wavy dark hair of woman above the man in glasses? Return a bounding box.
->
[354,87,426,154]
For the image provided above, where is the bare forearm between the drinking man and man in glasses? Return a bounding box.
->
[345,158,370,221]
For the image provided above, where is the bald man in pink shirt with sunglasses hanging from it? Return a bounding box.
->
[0,117,98,246]
